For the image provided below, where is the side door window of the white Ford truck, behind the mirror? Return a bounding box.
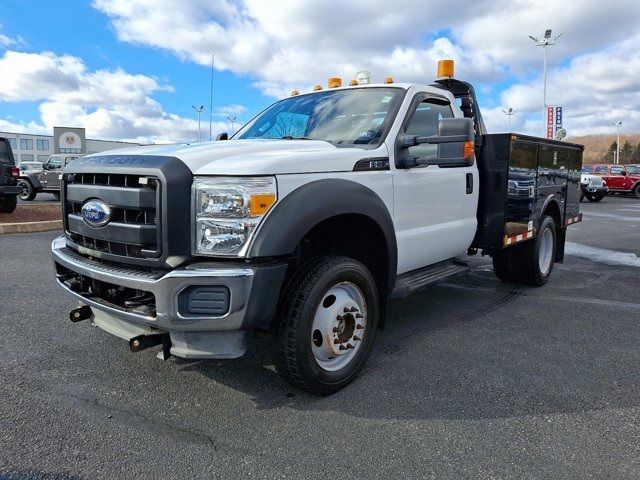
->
[405,99,453,158]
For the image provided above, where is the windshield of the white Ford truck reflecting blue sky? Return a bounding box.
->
[233,87,404,145]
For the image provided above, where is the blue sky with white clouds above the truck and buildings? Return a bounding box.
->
[0,0,640,141]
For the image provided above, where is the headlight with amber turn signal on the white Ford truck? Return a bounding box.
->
[193,177,278,256]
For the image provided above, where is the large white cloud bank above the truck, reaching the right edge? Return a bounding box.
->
[93,0,640,134]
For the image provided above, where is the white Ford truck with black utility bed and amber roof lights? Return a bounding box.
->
[52,61,583,394]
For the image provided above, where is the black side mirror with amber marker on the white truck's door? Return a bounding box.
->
[396,118,475,168]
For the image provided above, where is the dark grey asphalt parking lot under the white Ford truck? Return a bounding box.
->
[0,196,640,479]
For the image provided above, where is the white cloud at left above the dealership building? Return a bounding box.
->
[0,51,232,142]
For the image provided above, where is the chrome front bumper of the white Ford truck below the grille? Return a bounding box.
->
[51,237,286,358]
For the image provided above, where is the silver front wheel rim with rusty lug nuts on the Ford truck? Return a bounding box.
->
[311,282,367,372]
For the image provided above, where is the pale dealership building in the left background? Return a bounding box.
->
[0,127,140,163]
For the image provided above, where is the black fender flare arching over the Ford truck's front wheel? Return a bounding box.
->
[247,178,398,291]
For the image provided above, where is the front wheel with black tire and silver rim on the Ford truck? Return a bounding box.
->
[275,255,379,395]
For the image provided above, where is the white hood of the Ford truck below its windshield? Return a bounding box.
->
[91,140,388,175]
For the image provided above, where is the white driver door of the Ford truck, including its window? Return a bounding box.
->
[393,93,478,274]
